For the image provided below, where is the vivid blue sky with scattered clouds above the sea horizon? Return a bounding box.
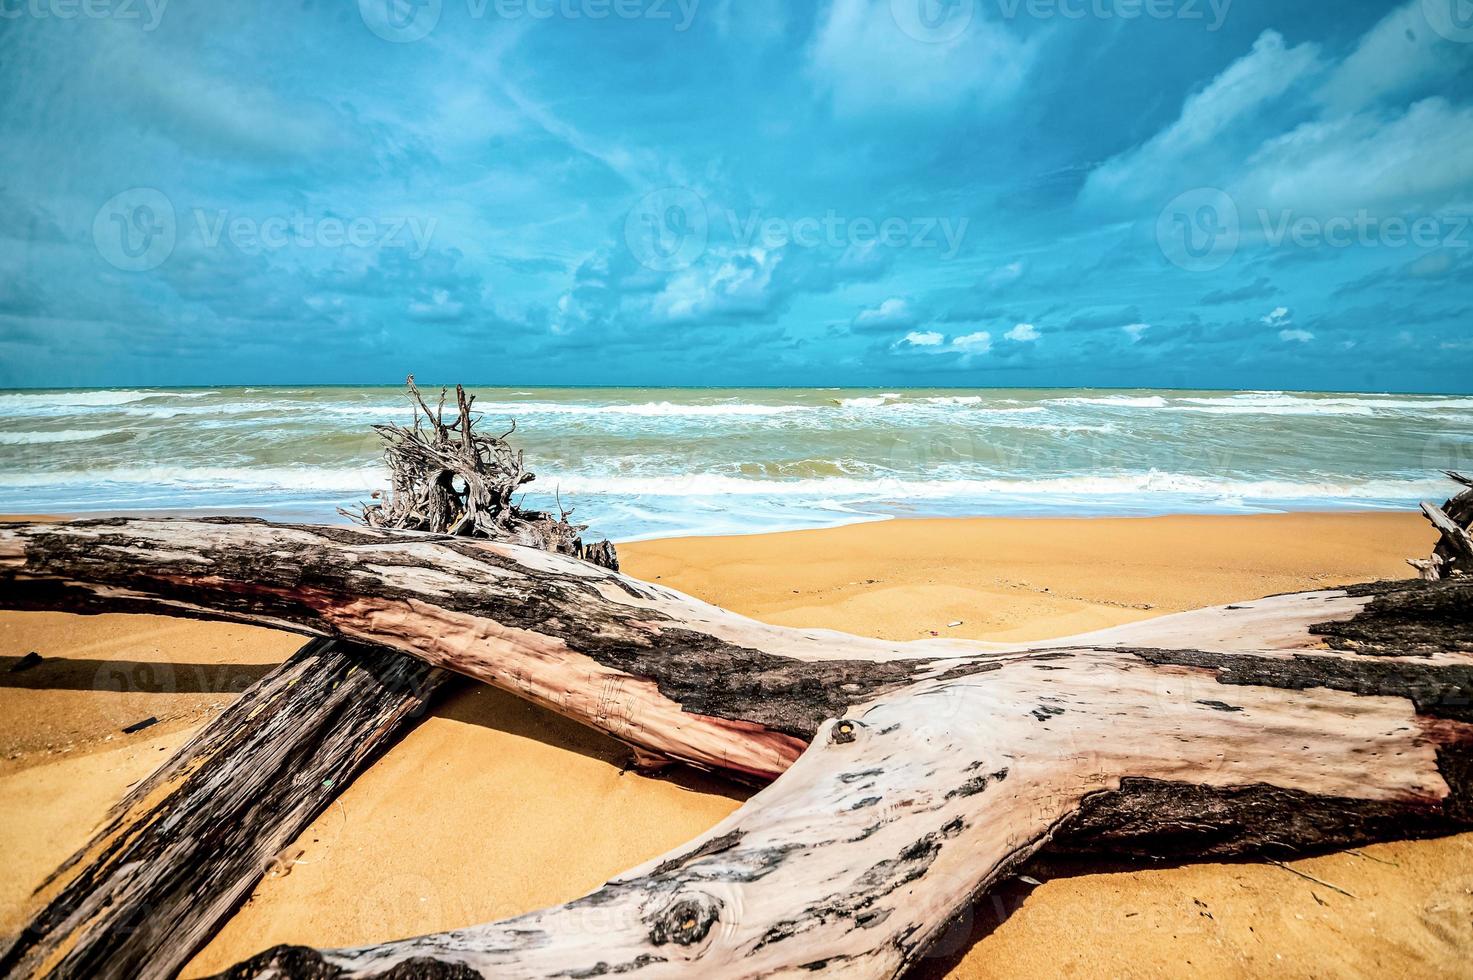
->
[0,0,1473,392]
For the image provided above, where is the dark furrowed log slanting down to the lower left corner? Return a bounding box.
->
[0,640,454,980]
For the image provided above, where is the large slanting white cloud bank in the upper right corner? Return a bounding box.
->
[1080,12,1473,219]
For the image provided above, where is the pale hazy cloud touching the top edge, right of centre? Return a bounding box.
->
[809,0,1036,115]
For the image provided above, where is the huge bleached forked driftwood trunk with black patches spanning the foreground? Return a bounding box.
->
[0,506,1473,977]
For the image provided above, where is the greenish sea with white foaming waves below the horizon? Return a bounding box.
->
[0,386,1473,541]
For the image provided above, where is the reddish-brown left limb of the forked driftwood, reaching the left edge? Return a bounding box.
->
[0,519,919,778]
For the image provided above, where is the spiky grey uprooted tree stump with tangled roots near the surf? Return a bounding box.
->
[340,374,619,570]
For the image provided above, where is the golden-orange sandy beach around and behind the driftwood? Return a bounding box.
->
[0,513,1473,977]
